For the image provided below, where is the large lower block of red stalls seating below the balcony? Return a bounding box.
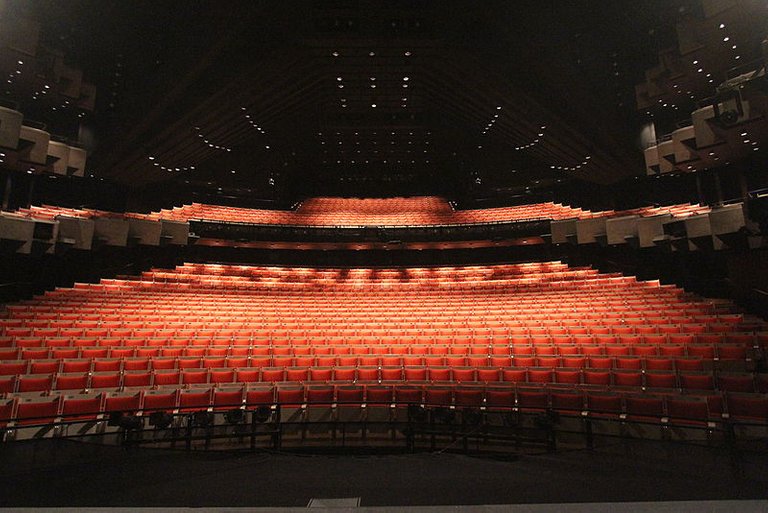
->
[0,262,768,425]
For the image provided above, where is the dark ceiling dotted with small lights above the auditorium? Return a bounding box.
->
[12,0,687,202]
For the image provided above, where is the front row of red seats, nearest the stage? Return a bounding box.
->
[0,384,768,428]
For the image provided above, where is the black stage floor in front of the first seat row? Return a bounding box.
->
[0,440,768,507]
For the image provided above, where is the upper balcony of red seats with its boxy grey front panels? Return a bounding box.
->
[0,201,720,254]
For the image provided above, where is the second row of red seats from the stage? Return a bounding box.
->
[0,366,768,394]
